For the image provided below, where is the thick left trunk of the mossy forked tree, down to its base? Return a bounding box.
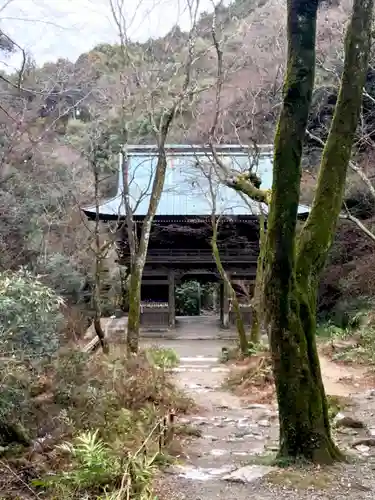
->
[264,0,366,463]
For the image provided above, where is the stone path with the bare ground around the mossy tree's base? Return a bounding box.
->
[151,341,375,500]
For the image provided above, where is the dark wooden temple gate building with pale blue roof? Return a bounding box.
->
[84,145,308,328]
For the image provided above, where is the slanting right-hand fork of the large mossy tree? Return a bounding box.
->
[297,0,374,280]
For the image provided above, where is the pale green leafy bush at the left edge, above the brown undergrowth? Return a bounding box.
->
[0,268,63,360]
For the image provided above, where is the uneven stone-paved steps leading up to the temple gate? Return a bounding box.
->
[163,341,277,500]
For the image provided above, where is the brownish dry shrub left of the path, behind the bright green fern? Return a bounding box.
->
[33,349,192,451]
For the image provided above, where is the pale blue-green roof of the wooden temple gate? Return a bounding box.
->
[84,145,308,218]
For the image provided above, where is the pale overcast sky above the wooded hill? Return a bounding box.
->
[0,0,228,71]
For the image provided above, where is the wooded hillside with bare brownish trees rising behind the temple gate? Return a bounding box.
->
[0,0,375,328]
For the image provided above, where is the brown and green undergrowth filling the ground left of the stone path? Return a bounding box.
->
[0,349,194,500]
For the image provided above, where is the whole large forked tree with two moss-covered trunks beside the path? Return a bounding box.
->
[264,0,373,463]
